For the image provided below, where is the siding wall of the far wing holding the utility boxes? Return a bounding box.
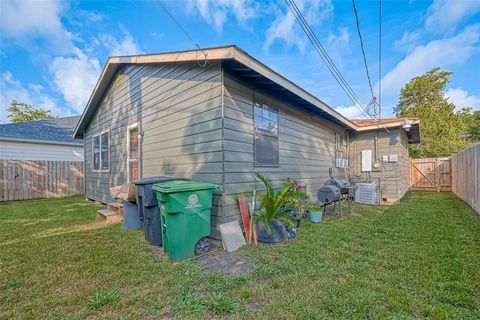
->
[349,129,410,203]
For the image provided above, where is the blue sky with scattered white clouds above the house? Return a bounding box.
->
[0,0,480,123]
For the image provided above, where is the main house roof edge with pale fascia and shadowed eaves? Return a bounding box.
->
[74,46,359,137]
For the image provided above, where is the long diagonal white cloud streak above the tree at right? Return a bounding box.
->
[382,24,480,95]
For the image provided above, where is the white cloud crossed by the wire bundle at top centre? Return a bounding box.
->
[265,0,333,51]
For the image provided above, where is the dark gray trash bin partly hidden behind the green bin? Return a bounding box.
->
[134,176,190,246]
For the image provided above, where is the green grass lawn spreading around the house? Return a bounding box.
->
[0,192,480,319]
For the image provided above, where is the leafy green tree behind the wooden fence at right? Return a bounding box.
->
[394,68,469,158]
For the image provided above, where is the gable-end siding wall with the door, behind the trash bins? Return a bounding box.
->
[85,62,223,230]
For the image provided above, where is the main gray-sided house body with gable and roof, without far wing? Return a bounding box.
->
[74,46,422,236]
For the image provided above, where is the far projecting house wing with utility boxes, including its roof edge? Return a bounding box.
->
[349,118,420,204]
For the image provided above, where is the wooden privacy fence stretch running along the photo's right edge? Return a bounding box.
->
[452,144,480,213]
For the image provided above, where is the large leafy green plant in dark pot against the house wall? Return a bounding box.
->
[254,172,298,243]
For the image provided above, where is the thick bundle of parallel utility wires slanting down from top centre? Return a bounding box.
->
[285,0,371,118]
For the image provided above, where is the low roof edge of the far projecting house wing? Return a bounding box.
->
[351,118,420,143]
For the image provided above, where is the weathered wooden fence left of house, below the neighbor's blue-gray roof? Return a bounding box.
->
[0,160,83,201]
